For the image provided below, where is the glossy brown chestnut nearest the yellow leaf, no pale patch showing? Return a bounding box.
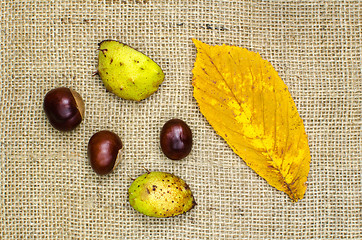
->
[160,119,192,160]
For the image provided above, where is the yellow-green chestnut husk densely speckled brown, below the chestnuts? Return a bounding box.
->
[128,172,196,217]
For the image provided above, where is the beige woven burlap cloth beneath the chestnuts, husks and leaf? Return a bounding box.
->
[0,0,362,240]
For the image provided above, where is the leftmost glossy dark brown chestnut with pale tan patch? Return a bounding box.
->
[43,87,85,131]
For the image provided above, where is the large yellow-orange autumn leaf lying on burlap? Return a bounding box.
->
[192,39,310,201]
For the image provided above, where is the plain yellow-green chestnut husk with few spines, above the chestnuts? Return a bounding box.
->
[98,40,165,101]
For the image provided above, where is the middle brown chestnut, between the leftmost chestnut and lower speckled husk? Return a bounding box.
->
[88,130,123,175]
